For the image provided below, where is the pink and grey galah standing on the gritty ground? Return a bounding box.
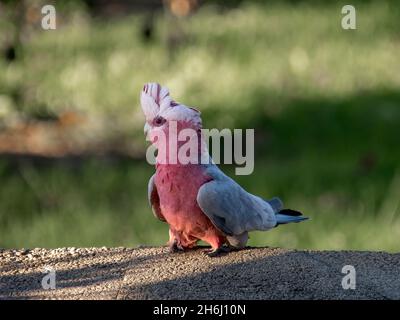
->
[140,83,307,256]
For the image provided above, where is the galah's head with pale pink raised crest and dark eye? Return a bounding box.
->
[140,83,202,144]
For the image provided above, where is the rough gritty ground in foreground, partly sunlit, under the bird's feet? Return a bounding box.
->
[0,247,400,299]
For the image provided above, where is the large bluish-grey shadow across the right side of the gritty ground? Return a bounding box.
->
[124,249,400,300]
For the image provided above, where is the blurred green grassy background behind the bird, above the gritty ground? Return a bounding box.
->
[0,0,400,251]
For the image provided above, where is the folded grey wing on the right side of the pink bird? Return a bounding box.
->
[197,165,276,235]
